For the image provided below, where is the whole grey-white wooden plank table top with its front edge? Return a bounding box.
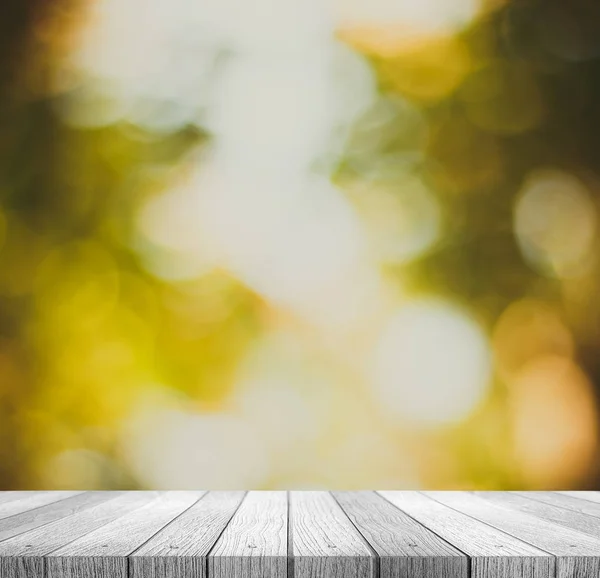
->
[0,491,600,578]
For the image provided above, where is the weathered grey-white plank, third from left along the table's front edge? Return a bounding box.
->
[129,492,245,578]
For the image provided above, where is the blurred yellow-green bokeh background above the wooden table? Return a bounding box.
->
[0,0,600,489]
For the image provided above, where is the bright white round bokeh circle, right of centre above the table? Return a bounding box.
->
[373,301,491,426]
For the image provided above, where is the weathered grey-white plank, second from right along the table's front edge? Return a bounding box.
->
[378,492,555,578]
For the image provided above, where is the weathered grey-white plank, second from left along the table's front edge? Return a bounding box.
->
[46,492,205,578]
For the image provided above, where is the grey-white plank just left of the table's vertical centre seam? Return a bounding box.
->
[208,492,288,578]
